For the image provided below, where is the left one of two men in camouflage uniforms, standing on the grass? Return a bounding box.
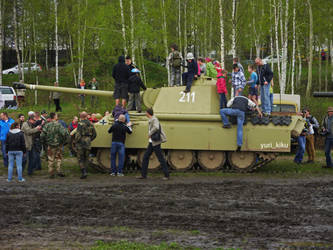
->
[41,113,69,178]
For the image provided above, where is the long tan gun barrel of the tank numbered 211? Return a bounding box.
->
[22,83,113,97]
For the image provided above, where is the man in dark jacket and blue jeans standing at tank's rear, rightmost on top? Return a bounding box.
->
[255,57,273,115]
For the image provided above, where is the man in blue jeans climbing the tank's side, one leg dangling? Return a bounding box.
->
[220,96,262,152]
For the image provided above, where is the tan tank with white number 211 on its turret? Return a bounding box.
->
[18,78,304,172]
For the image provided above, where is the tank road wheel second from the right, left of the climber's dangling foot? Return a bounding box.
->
[198,151,227,171]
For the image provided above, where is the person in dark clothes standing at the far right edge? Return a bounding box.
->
[322,107,333,168]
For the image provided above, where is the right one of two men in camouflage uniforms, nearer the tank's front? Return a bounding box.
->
[74,112,96,179]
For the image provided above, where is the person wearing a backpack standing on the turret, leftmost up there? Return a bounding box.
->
[168,44,182,87]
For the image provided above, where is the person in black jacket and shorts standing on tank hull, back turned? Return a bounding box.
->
[112,56,130,108]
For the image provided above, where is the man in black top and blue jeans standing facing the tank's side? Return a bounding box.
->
[108,115,132,176]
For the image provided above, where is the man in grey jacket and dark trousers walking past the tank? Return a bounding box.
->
[137,108,169,181]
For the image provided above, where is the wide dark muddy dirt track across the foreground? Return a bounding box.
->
[0,176,333,249]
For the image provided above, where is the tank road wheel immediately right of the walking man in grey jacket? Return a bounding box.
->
[168,150,195,171]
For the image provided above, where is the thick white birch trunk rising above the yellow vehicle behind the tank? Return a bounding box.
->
[278,0,289,94]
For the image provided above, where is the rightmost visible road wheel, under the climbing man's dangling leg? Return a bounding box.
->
[228,151,257,172]
